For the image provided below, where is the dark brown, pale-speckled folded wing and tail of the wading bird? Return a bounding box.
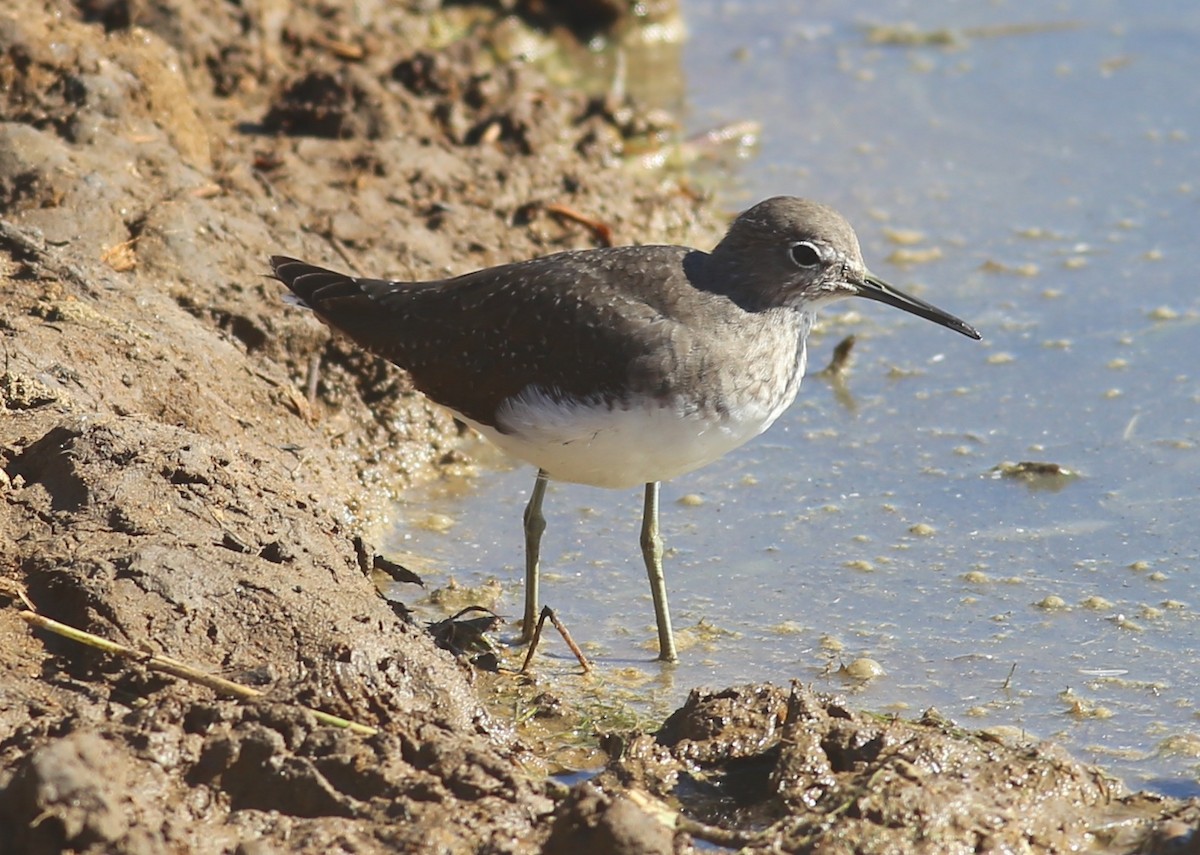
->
[271,246,712,428]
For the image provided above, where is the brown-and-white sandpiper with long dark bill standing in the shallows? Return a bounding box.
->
[270,196,980,662]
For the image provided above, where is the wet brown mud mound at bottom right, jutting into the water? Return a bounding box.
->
[595,686,1200,855]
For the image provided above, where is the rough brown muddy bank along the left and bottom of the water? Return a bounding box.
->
[0,0,1200,853]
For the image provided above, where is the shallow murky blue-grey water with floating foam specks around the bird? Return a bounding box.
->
[392,0,1200,795]
